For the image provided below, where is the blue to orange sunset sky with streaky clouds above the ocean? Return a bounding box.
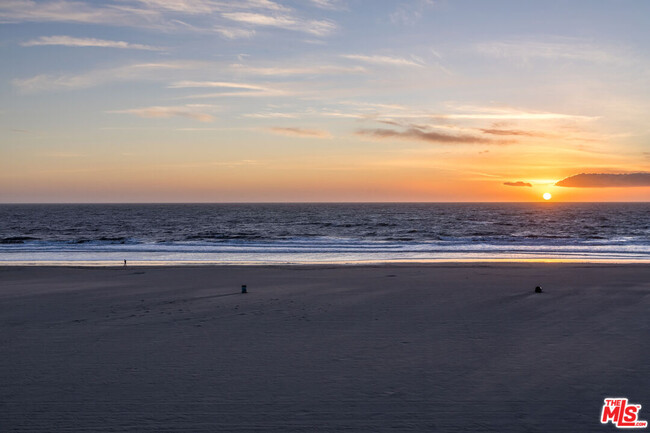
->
[0,0,650,203]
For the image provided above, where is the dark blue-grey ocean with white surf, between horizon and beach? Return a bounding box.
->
[0,203,650,265]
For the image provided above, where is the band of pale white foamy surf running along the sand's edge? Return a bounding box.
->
[0,238,650,263]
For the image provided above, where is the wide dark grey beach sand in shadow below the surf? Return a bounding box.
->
[0,263,650,433]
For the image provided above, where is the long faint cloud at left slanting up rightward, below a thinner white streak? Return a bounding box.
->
[12,62,195,93]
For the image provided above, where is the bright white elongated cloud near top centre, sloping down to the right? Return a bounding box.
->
[221,12,336,36]
